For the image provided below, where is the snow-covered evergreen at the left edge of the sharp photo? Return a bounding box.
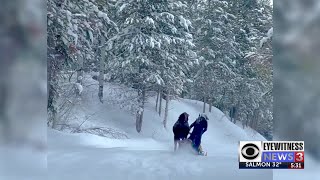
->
[47,0,117,129]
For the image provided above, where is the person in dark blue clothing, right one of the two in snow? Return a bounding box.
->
[188,114,209,153]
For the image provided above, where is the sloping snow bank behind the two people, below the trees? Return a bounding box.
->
[57,74,265,144]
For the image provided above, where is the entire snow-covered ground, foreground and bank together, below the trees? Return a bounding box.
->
[48,73,272,180]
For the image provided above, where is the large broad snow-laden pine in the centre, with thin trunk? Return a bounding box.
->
[111,0,195,132]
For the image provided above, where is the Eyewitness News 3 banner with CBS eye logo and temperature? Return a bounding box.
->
[239,141,304,169]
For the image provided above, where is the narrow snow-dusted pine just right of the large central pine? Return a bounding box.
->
[190,1,239,111]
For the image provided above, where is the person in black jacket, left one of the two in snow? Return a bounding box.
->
[172,112,190,151]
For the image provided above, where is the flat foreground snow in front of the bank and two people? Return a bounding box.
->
[48,126,272,180]
